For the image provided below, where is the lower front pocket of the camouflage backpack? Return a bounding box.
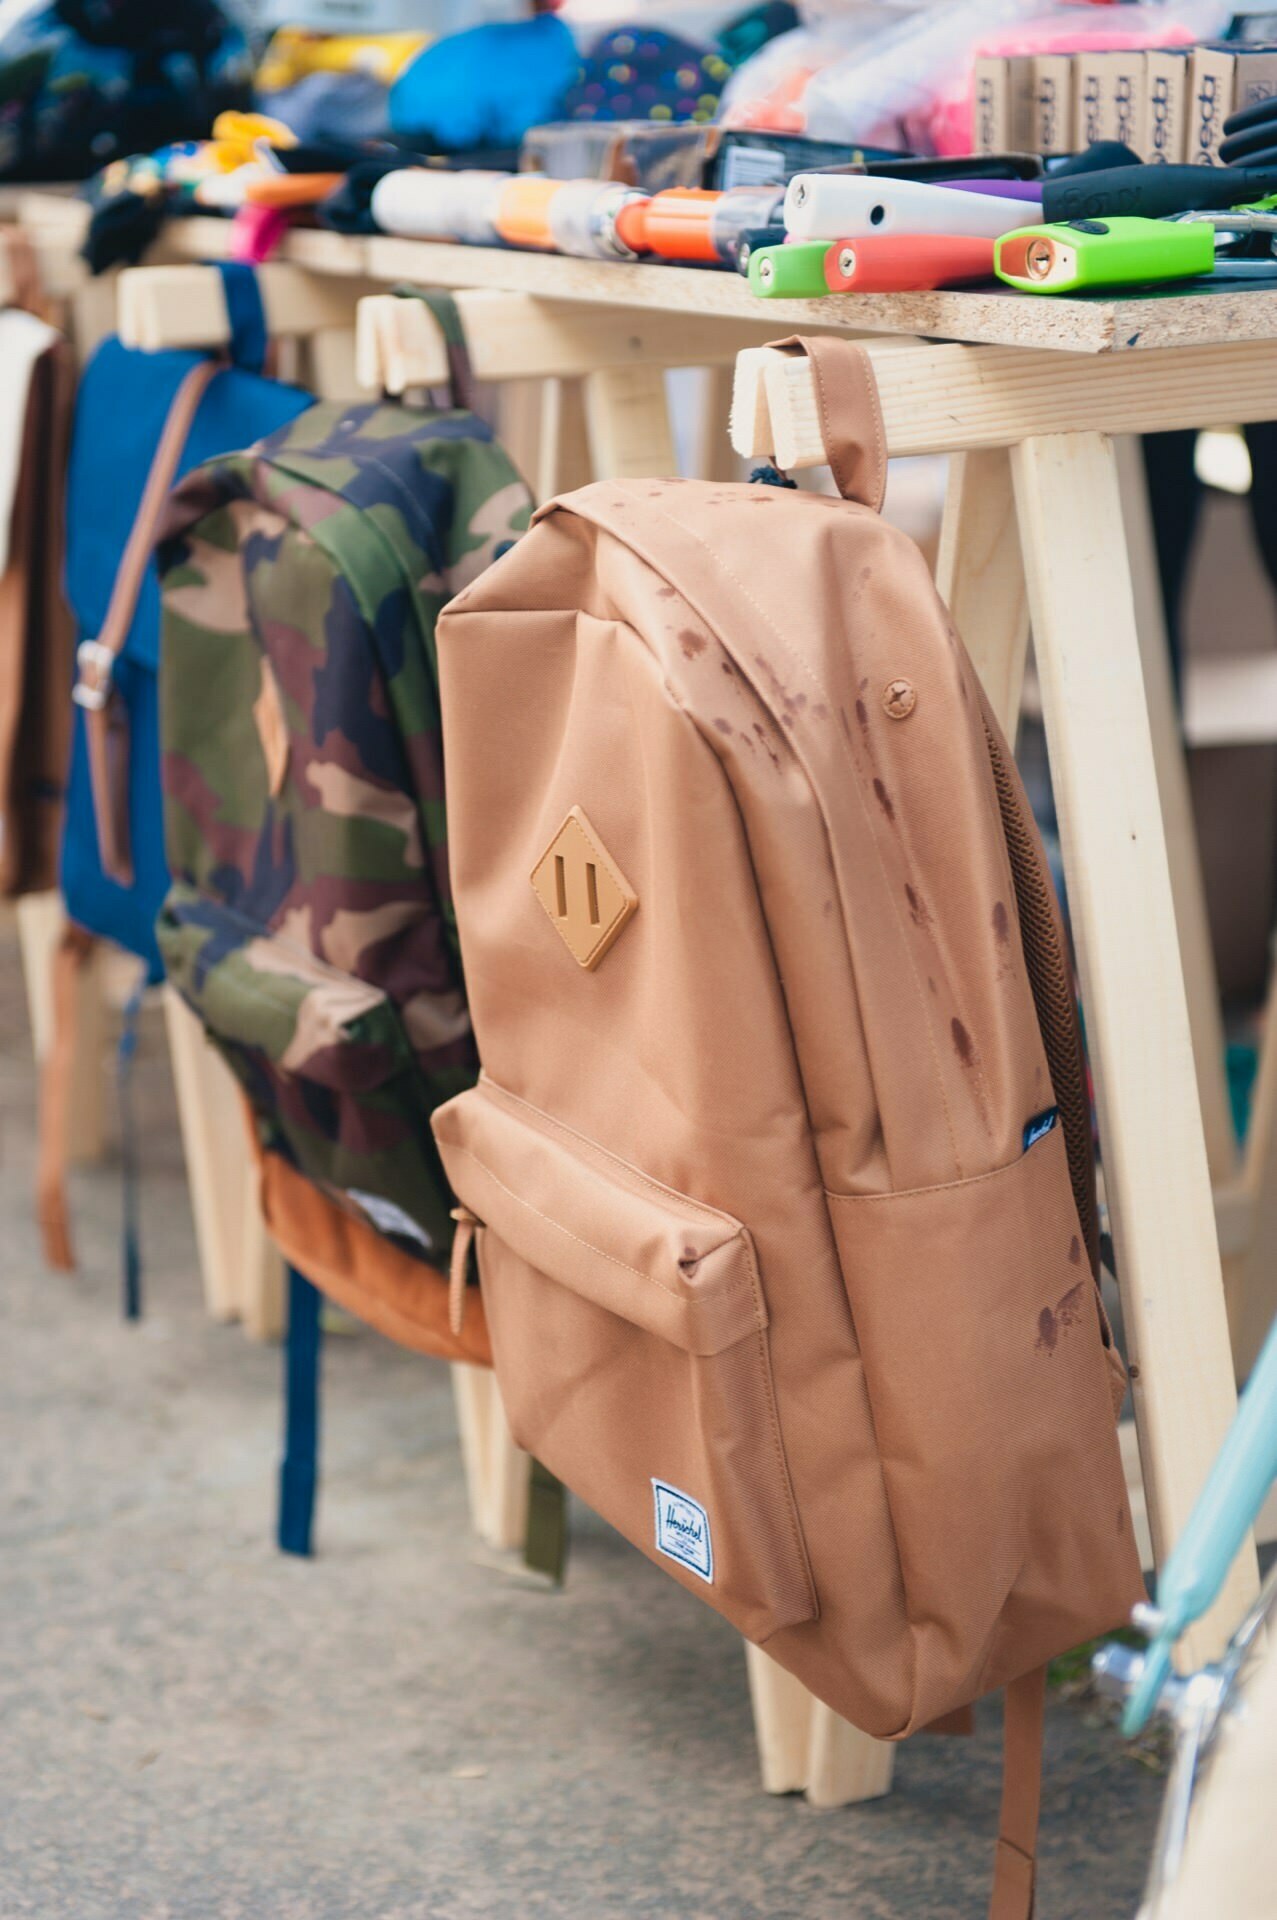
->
[159,885,451,1263]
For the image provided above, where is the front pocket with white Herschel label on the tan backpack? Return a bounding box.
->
[434,1077,816,1642]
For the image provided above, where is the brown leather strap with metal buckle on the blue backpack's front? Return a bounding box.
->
[75,359,221,887]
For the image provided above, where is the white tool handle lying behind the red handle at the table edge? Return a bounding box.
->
[785,173,1043,240]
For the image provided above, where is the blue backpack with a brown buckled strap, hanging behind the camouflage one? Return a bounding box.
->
[61,267,313,983]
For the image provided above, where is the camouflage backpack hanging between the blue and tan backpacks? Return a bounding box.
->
[157,403,532,1261]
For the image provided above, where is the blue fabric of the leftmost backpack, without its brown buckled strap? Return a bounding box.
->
[61,326,313,981]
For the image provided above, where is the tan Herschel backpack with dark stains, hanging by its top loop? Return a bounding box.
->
[434,340,1143,1920]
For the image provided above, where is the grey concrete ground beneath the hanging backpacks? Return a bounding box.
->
[0,924,1162,1920]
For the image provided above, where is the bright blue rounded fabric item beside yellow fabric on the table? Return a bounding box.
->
[390,13,580,154]
